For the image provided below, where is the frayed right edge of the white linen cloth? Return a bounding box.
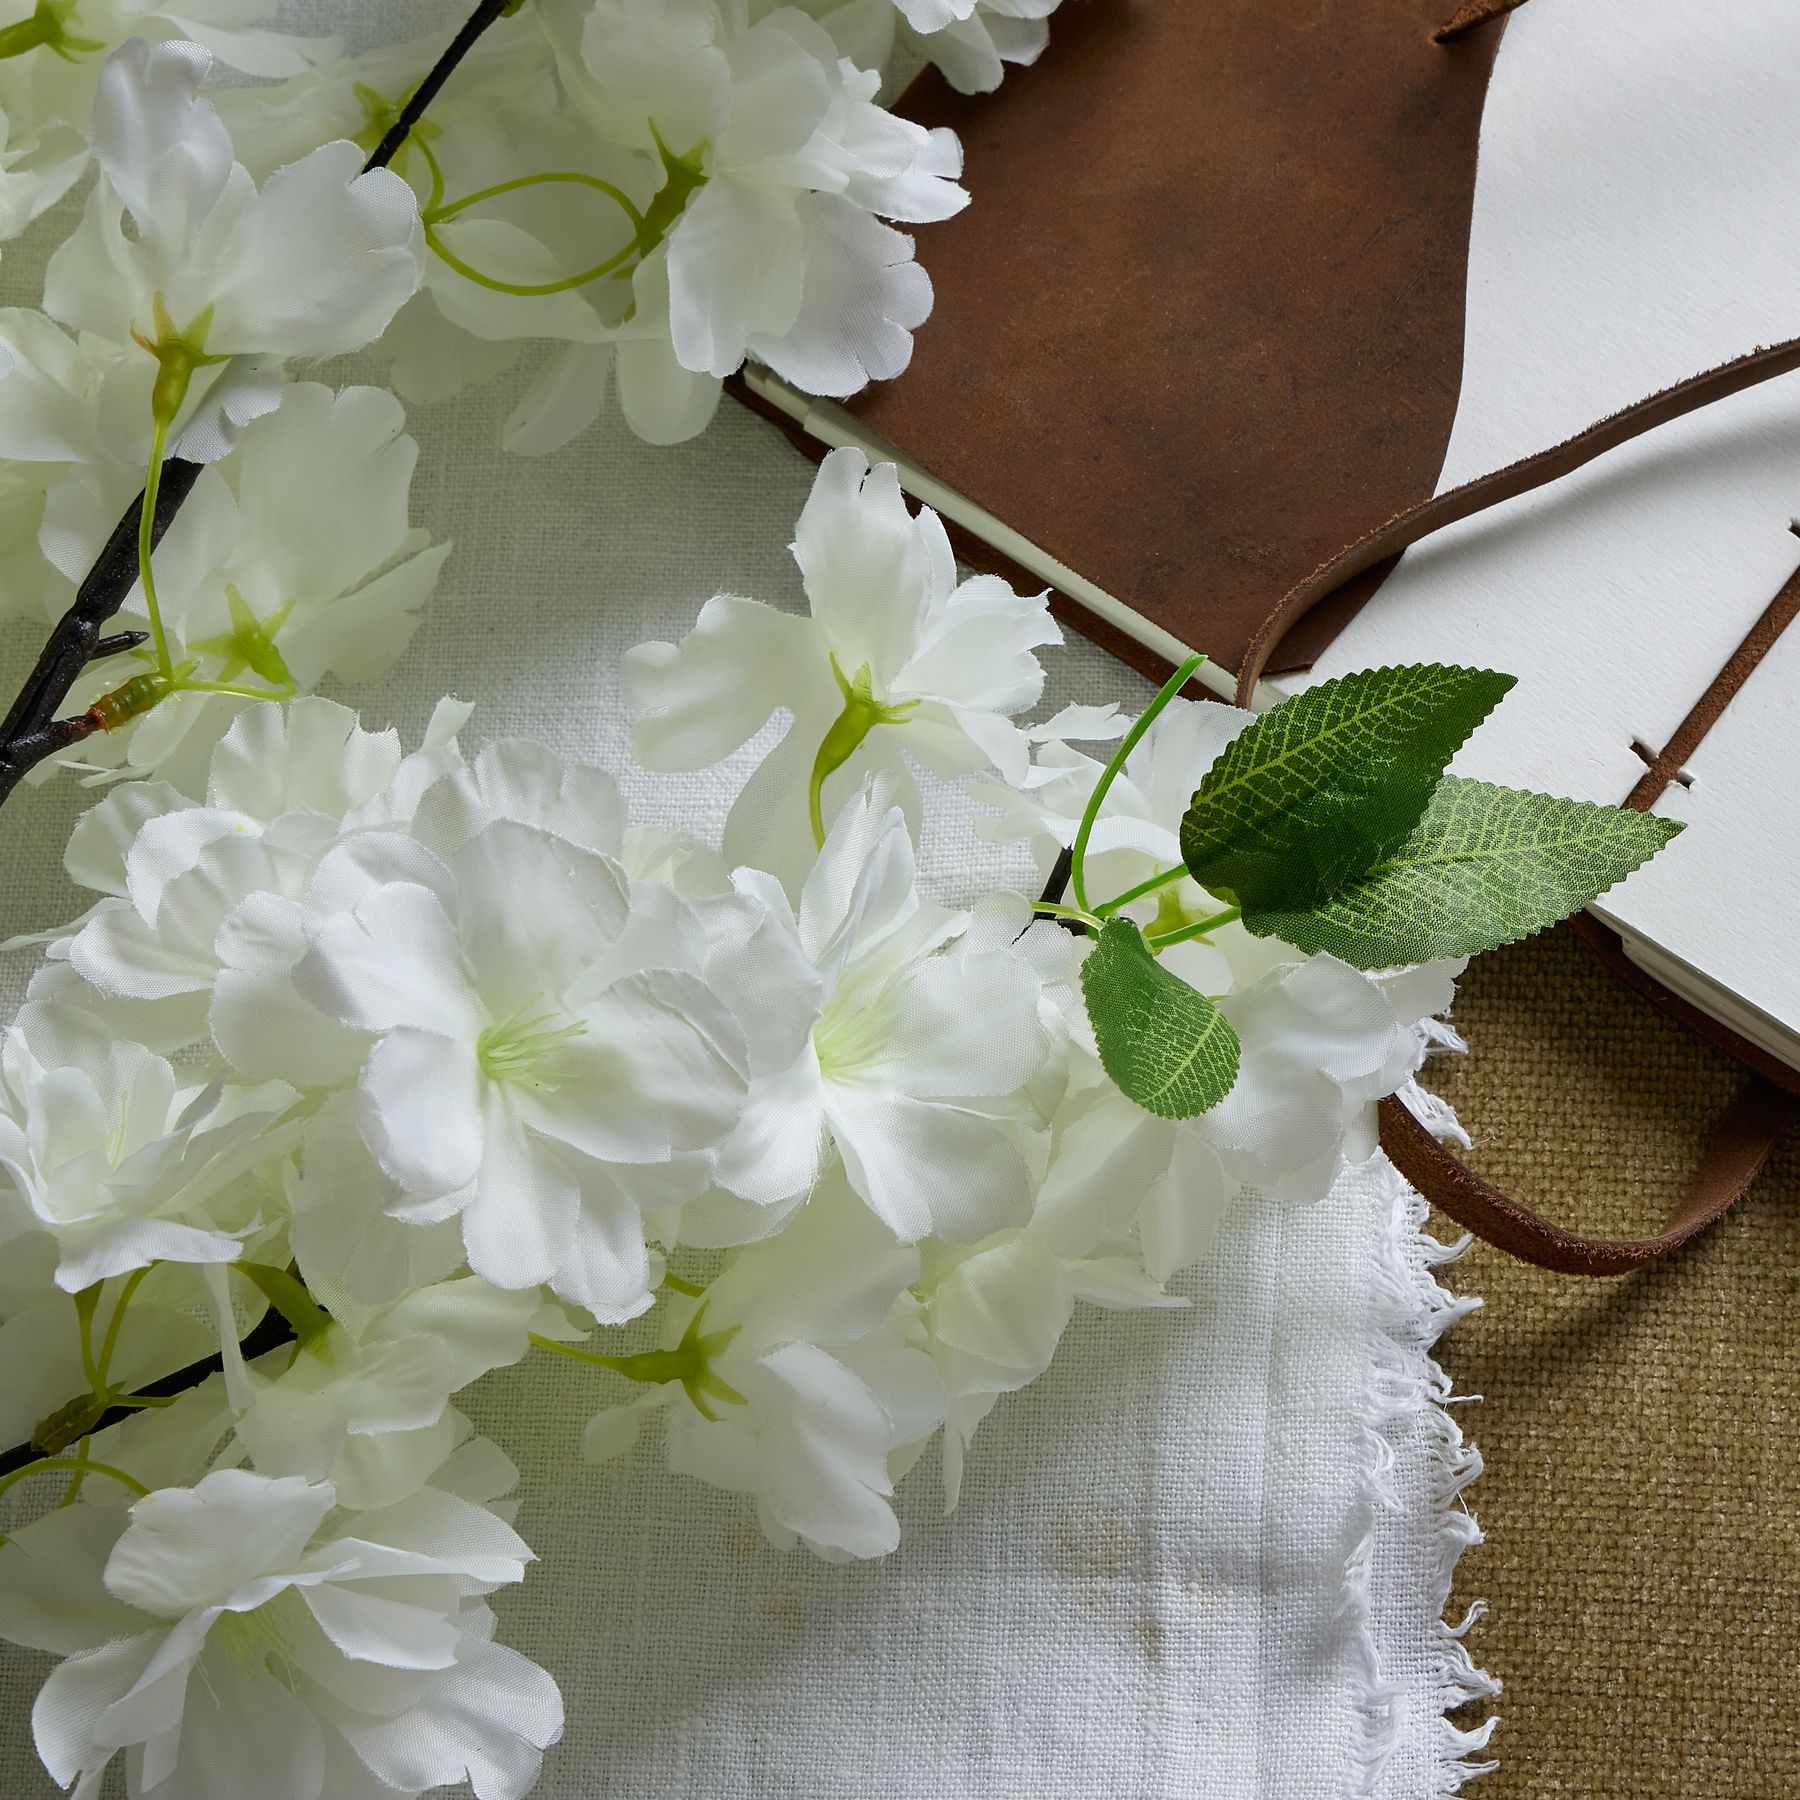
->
[1343,1154,1499,1800]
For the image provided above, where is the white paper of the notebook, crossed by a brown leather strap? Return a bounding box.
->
[1314,0,1800,1028]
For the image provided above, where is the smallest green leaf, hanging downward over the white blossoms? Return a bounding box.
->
[1082,918,1238,1120]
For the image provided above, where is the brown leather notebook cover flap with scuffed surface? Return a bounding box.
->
[734,0,1499,687]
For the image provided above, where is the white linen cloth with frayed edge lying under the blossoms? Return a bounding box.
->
[0,4,1490,1800]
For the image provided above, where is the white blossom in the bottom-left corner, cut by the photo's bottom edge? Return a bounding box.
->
[0,1445,562,1800]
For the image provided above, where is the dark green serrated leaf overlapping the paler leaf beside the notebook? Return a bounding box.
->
[1181,662,1512,913]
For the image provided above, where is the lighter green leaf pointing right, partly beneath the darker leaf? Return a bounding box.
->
[1244,776,1681,968]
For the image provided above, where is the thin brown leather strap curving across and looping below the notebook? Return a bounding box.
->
[1237,334,1800,1274]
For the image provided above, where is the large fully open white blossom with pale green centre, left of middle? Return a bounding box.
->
[293,821,749,1319]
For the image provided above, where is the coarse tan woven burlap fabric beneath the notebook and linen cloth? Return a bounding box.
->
[1431,932,1800,1800]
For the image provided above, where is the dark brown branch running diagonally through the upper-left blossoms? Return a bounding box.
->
[0,0,517,805]
